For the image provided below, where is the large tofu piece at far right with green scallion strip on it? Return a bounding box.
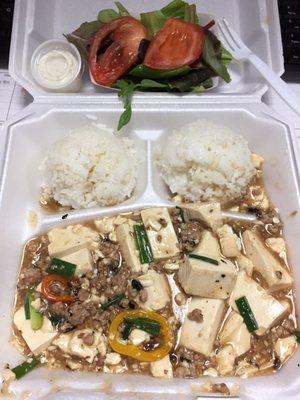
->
[229,271,289,335]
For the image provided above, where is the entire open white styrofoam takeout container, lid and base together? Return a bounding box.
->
[0,0,300,400]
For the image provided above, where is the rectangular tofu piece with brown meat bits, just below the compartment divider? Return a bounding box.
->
[141,207,180,260]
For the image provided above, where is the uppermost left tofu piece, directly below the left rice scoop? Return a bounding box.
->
[48,225,98,258]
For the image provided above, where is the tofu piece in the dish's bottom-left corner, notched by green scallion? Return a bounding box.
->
[13,307,58,355]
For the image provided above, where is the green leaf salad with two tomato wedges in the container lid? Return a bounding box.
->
[65,0,232,130]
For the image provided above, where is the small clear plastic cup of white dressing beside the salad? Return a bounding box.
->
[31,39,84,92]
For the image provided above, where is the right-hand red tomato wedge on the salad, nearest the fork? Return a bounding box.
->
[144,18,204,69]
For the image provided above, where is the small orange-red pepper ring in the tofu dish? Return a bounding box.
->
[41,274,75,303]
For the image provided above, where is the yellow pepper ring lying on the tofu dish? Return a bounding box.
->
[108,310,173,362]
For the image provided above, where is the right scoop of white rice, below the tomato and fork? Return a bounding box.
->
[156,120,255,201]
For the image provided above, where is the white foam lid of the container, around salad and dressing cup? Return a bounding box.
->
[9,0,283,103]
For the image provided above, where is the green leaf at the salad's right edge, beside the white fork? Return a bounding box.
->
[202,29,231,83]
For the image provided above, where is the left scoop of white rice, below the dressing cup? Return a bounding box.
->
[41,124,137,209]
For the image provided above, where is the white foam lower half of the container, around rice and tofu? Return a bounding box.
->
[0,104,300,400]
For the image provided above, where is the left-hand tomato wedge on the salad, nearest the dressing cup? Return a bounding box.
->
[88,17,147,86]
